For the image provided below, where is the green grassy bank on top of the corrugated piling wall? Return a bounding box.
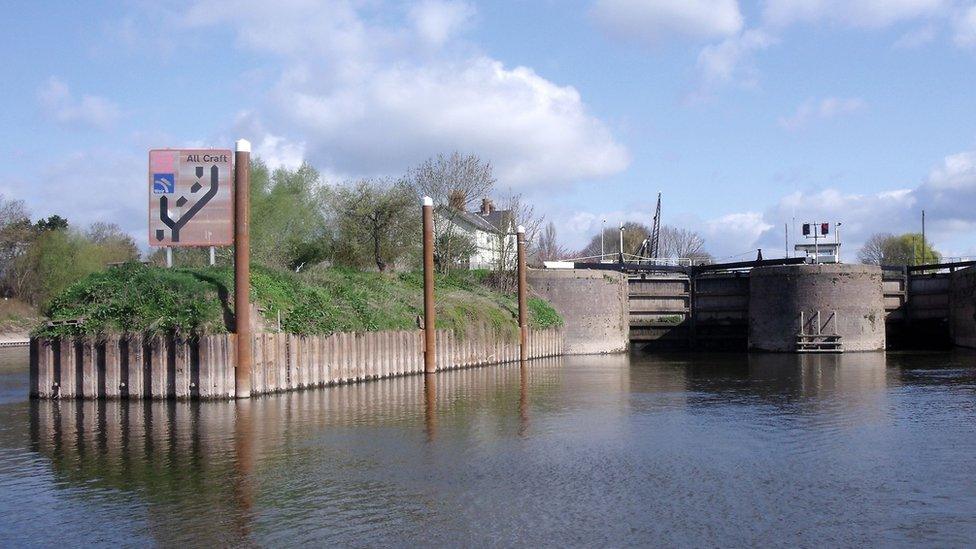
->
[35,264,562,336]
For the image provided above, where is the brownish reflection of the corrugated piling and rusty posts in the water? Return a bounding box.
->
[22,359,561,545]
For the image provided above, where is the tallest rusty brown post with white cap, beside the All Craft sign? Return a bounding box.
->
[234,139,252,398]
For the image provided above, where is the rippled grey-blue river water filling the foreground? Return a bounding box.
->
[0,350,976,547]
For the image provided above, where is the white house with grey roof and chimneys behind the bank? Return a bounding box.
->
[434,195,516,269]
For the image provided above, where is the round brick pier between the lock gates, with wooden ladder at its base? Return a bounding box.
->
[749,264,885,351]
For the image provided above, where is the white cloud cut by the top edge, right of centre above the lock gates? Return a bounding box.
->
[592,0,742,45]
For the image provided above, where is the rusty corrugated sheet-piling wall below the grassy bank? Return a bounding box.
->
[30,329,563,400]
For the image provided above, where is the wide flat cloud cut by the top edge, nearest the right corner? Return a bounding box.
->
[763,0,948,28]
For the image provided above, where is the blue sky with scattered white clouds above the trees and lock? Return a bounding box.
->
[0,0,976,261]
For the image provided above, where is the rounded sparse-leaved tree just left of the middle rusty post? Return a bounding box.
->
[331,179,421,272]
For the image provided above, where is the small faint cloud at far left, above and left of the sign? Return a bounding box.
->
[37,76,121,130]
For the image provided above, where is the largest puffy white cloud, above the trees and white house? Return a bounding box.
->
[272,57,629,186]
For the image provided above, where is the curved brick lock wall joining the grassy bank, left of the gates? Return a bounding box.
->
[527,269,630,354]
